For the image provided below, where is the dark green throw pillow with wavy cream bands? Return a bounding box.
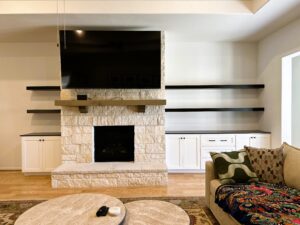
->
[210,150,258,184]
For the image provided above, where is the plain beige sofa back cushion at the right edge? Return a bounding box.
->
[283,143,300,190]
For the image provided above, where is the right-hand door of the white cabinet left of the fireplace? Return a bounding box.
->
[42,138,61,172]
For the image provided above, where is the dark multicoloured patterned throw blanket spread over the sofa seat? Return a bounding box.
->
[215,182,300,225]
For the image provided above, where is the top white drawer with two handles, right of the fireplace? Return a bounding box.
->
[201,135,235,147]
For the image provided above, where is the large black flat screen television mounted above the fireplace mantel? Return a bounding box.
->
[60,30,161,89]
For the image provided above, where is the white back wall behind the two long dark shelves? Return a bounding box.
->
[166,38,262,130]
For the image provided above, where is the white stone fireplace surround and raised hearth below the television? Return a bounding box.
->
[52,34,167,188]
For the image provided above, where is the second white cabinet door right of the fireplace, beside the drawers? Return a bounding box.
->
[180,135,200,169]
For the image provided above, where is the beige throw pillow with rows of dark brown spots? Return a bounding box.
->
[245,146,284,184]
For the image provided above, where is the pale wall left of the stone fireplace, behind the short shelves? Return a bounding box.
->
[0,43,60,169]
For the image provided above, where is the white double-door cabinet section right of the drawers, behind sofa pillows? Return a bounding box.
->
[236,134,271,150]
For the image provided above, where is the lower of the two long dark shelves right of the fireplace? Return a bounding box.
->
[165,107,265,112]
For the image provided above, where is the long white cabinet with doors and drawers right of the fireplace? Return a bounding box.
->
[166,133,271,172]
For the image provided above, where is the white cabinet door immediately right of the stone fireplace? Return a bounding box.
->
[166,134,181,169]
